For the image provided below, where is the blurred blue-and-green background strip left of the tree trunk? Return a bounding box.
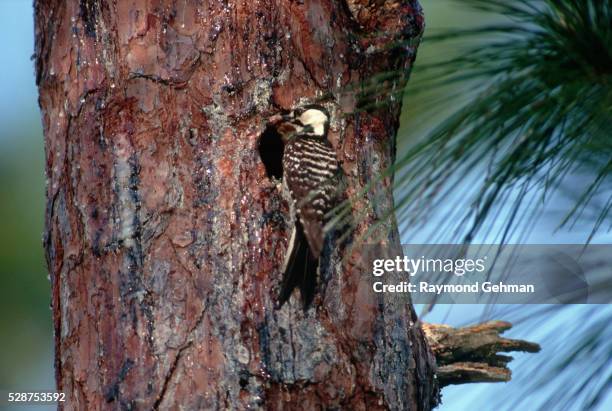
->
[0,0,53,396]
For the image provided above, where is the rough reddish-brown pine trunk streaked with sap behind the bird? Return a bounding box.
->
[35,0,437,410]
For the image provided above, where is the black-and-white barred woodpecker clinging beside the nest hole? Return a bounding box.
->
[274,104,341,310]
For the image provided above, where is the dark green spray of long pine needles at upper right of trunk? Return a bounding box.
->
[396,0,612,242]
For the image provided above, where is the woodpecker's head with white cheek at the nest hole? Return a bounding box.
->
[270,104,329,140]
